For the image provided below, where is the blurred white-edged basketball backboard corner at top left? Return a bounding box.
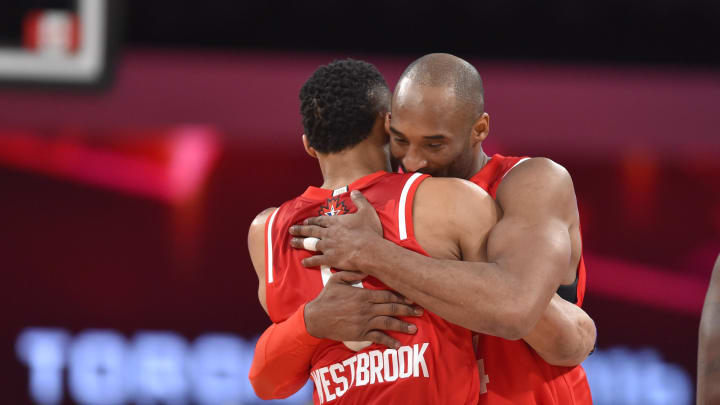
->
[0,0,122,87]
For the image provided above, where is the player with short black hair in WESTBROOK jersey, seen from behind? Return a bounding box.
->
[248,60,499,405]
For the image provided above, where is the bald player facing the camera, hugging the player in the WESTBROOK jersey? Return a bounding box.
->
[291,54,592,404]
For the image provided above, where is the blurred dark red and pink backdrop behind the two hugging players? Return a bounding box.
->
[0,51,720,397]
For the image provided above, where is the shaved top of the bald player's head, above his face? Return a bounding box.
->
[394,53,485,120]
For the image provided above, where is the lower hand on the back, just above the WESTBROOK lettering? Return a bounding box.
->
[305,271,423,349]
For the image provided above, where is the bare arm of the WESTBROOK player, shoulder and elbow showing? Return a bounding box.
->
[413,172,596,366]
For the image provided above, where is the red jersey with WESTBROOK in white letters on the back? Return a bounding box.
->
[265,172,480,405]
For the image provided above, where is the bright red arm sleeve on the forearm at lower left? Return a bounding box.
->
[249,305,321,399]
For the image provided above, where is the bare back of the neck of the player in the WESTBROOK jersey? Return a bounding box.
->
[318,144,390,190]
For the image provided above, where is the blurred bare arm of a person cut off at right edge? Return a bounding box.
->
[697,251,720,405]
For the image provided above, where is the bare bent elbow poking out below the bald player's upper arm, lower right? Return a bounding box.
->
[523,295,597,367]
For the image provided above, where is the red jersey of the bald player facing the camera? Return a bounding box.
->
[470,154,592,405]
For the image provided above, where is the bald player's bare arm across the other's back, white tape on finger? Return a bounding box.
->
[295,159,577,339]
